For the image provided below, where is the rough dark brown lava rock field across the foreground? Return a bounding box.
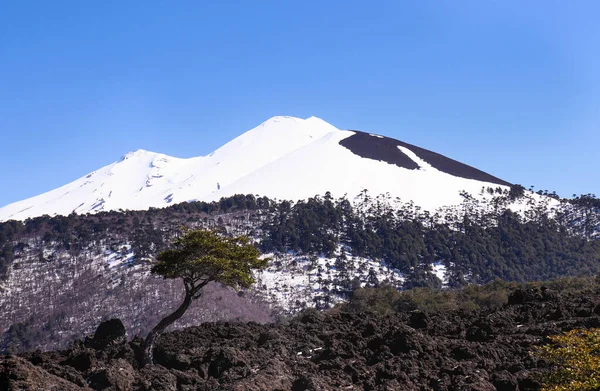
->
[0,290,600,391]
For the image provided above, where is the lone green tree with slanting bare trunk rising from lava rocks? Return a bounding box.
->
[144,229,268,364]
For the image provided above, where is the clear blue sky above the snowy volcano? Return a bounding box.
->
[0,0,600,206]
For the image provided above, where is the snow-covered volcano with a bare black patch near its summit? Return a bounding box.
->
[0,117,510,221]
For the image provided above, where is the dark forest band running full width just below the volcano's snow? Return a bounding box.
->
[0,190,600,288]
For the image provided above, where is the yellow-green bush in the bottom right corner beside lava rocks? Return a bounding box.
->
[537,329,600,391]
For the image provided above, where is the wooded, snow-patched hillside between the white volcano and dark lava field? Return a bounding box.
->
[0,189,600,351]
